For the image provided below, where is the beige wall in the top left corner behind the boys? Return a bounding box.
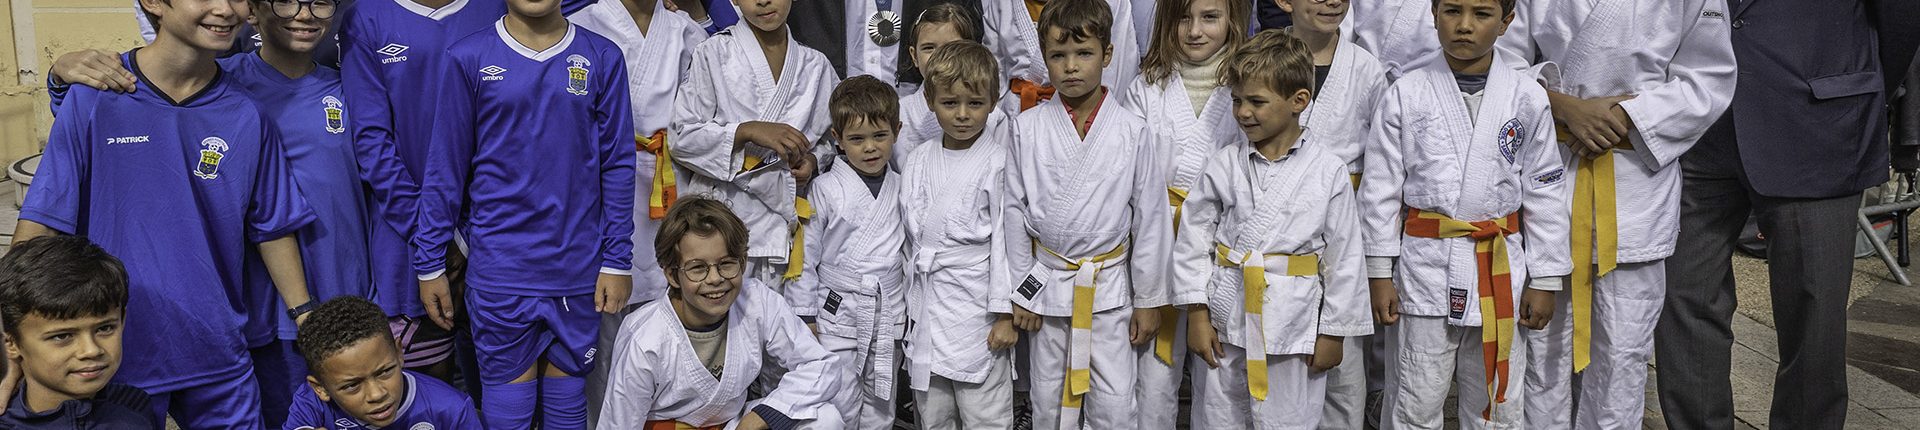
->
[0,0,140,163]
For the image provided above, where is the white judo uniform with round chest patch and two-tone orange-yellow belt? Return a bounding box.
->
[1359,54,1572,428]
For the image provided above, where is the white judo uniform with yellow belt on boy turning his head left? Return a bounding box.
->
[1167,138,1373,428]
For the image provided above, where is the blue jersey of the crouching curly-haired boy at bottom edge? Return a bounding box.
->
[284,370,480,430]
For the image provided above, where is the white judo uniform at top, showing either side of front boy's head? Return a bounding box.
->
[979,0,1128,115]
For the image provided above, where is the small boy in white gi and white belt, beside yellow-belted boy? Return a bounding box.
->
[900,39,1020,430]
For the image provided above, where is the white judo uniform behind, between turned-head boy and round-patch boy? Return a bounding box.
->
[1300,36,1386,430]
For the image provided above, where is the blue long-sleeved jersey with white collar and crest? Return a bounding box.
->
[420,21,634,298]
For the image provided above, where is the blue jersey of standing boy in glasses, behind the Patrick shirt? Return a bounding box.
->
[221,54,382,340]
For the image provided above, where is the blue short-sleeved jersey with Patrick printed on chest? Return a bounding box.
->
[19,52,315,392]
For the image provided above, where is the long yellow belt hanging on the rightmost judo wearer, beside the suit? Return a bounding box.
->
[1557,131,1634,372]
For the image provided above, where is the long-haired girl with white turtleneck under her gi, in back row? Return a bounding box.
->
[1125,0,1254,430]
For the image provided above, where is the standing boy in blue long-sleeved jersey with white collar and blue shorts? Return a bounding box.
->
[417,0,634,428]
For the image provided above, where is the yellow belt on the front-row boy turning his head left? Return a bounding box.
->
[1213,244,1319,401]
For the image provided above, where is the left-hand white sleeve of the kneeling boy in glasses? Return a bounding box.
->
[599,324,660,428]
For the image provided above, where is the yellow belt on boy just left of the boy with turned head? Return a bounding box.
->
[1033,240,1127,428]
